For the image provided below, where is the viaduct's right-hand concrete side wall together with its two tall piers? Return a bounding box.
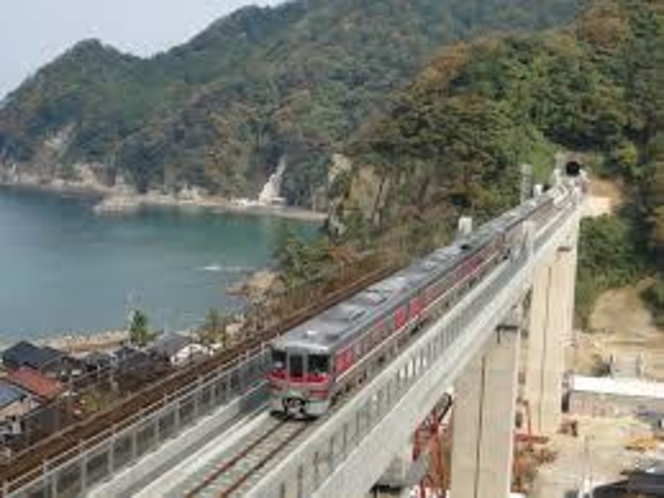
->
[248,184,583,498]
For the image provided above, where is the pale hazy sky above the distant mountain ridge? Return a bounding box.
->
[0,0,283,99]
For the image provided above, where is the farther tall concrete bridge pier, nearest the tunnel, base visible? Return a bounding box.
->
[525,233,576,434]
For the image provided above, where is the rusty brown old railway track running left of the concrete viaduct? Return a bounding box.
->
[0,265,398,495]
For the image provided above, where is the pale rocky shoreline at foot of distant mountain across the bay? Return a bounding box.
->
[0,176,327,223]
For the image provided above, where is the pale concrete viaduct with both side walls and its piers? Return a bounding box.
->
[2,172,584,498]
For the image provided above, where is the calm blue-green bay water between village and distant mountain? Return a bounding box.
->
[0,189,316,343]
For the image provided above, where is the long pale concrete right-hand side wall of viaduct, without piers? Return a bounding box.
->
[248,205,579,498]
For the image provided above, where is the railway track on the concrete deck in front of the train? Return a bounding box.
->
[178,417,309,498]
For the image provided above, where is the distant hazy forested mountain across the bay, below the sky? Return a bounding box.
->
[0,0,581,205]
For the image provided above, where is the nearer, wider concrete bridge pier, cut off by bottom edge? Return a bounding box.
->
[450,329,520,498]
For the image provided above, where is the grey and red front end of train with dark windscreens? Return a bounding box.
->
[268,319,333,418]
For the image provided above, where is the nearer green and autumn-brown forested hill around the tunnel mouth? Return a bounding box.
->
[333,0,664,320]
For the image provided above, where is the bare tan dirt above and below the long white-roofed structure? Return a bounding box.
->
[532,274,664,498]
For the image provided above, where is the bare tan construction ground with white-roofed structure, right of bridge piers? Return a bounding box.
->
[515,283,664,498]
